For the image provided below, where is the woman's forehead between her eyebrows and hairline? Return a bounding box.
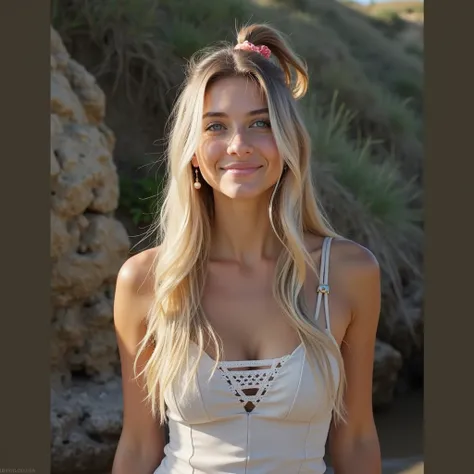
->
[204,77,267,115]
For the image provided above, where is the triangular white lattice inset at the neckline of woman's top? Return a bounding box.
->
[219,354,292,412]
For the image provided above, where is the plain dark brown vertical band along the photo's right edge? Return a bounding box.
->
[424,2,474,474]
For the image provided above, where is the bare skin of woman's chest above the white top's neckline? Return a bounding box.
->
[202,264,350,360]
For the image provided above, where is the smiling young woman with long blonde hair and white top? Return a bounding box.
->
[113,25,381,474]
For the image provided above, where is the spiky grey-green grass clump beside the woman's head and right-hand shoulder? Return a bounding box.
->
[307,93,423,323]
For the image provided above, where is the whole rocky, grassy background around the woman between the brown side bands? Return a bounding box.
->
[51,0,424,474]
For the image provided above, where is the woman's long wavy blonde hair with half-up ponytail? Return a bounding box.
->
[137,25,345,423]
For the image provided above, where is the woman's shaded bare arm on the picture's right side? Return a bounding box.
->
[329,247,382,474]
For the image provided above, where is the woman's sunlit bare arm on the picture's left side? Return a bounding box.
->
[112,250,165,474]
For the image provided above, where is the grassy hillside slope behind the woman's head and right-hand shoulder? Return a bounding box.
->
[53,0,423,336]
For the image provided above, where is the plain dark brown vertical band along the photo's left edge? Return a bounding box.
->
[0,0,51,474]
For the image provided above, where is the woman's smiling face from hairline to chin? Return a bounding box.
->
[192,77,283,199]
